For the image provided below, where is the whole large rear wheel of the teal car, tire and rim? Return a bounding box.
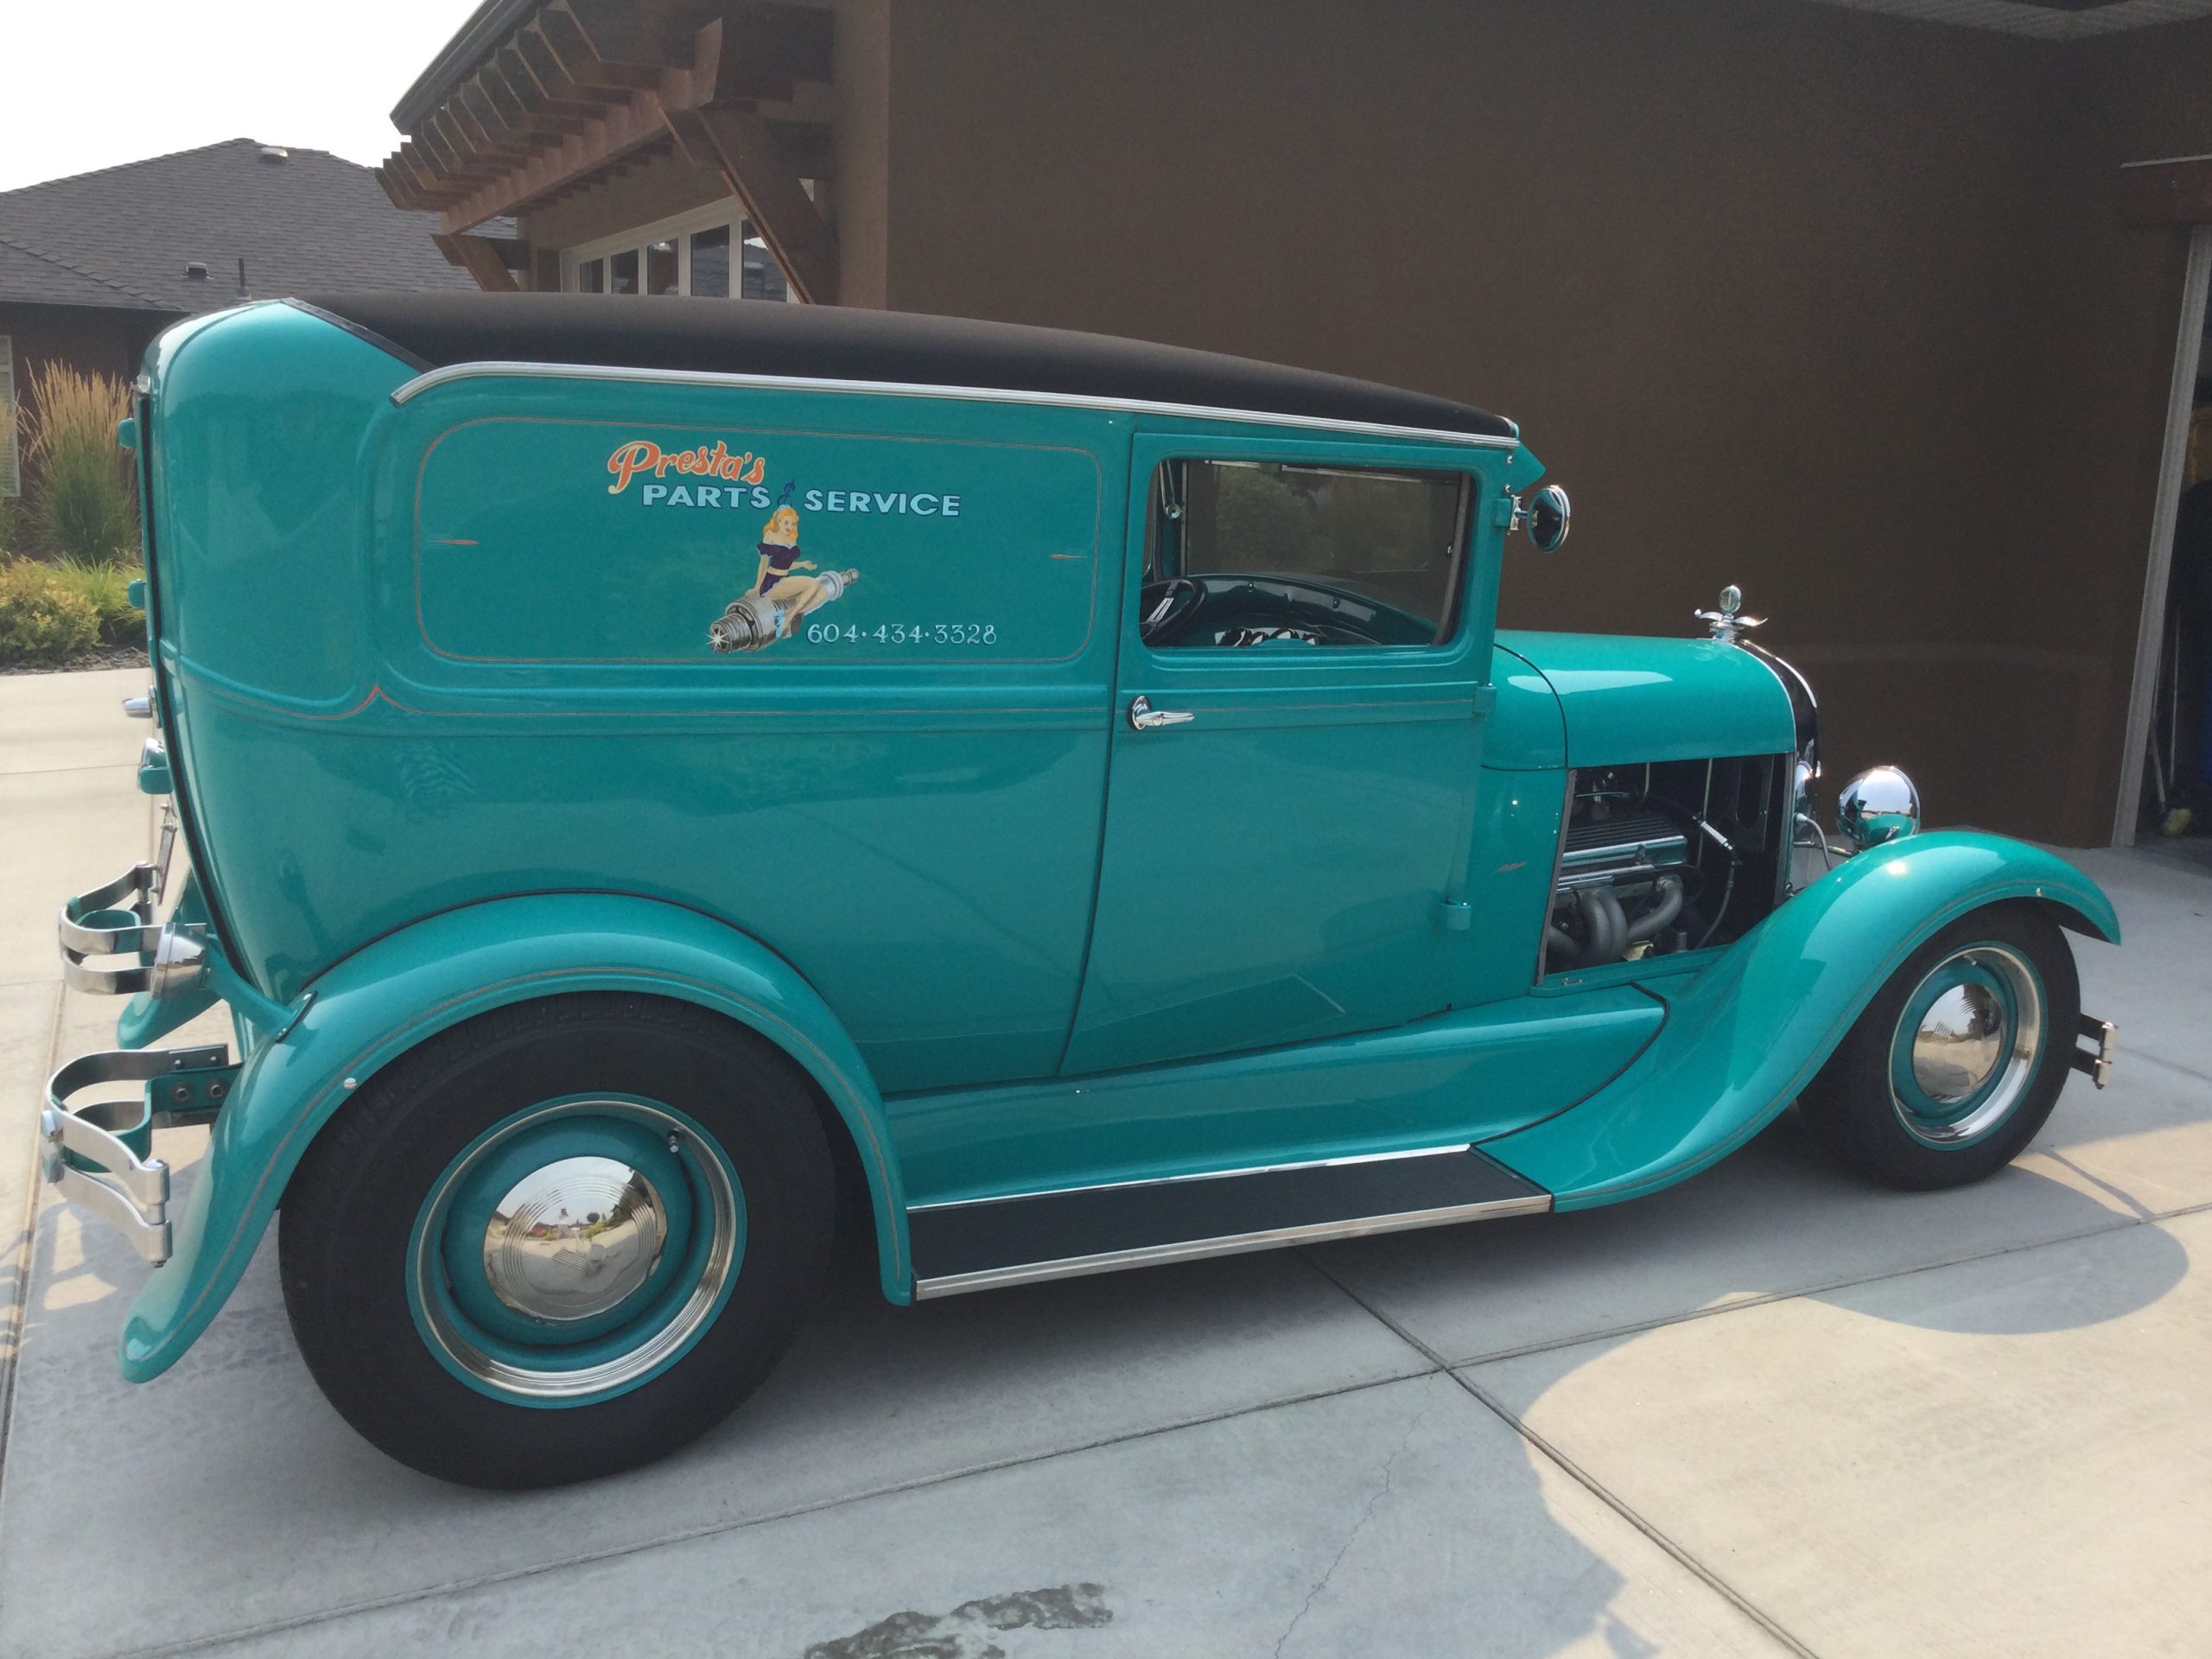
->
[279,995,836,1486]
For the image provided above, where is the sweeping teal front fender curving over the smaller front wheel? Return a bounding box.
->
[1482,830,2119,1210]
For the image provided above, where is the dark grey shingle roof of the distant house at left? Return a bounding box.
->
[0,139,475,315]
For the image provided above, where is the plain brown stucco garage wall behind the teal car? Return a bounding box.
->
[887,0,2212,842]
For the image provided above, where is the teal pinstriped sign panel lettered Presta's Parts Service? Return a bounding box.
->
[416,418,1103,671]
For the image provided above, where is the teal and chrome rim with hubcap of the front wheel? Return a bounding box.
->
[1889,940,2050,1150]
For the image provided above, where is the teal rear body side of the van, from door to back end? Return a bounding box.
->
[157,308,1128,1089]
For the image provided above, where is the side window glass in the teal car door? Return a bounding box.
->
[1139,460,1469,648]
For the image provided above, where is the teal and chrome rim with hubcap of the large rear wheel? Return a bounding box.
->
[407,1095,746,1407]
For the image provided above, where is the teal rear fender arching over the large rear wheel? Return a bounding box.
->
[122,893,912,1382]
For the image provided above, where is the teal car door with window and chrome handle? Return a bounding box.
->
[1062,431,1506,1075]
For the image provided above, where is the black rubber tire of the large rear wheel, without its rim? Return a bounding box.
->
[279,993,836,1489]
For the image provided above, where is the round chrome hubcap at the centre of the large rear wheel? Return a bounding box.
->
[485,1157,668,1325]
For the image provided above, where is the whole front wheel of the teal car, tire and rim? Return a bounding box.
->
[1798,905,2082,1190]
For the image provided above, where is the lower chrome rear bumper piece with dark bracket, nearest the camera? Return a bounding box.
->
[38,1044,238,1268]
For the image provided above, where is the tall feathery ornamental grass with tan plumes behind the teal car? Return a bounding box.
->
[27,363,139,564]
